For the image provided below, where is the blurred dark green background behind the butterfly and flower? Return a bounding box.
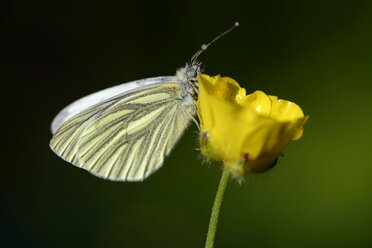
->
[0,0,372,247]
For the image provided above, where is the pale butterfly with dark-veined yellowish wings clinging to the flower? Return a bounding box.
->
[49,23,238,181]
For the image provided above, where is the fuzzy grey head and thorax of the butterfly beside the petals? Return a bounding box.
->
[176,61,203,102]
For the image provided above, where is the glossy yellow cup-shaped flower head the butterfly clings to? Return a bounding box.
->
[197,74,308,176]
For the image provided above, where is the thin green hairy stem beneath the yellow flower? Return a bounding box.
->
[205,168,230,248]
